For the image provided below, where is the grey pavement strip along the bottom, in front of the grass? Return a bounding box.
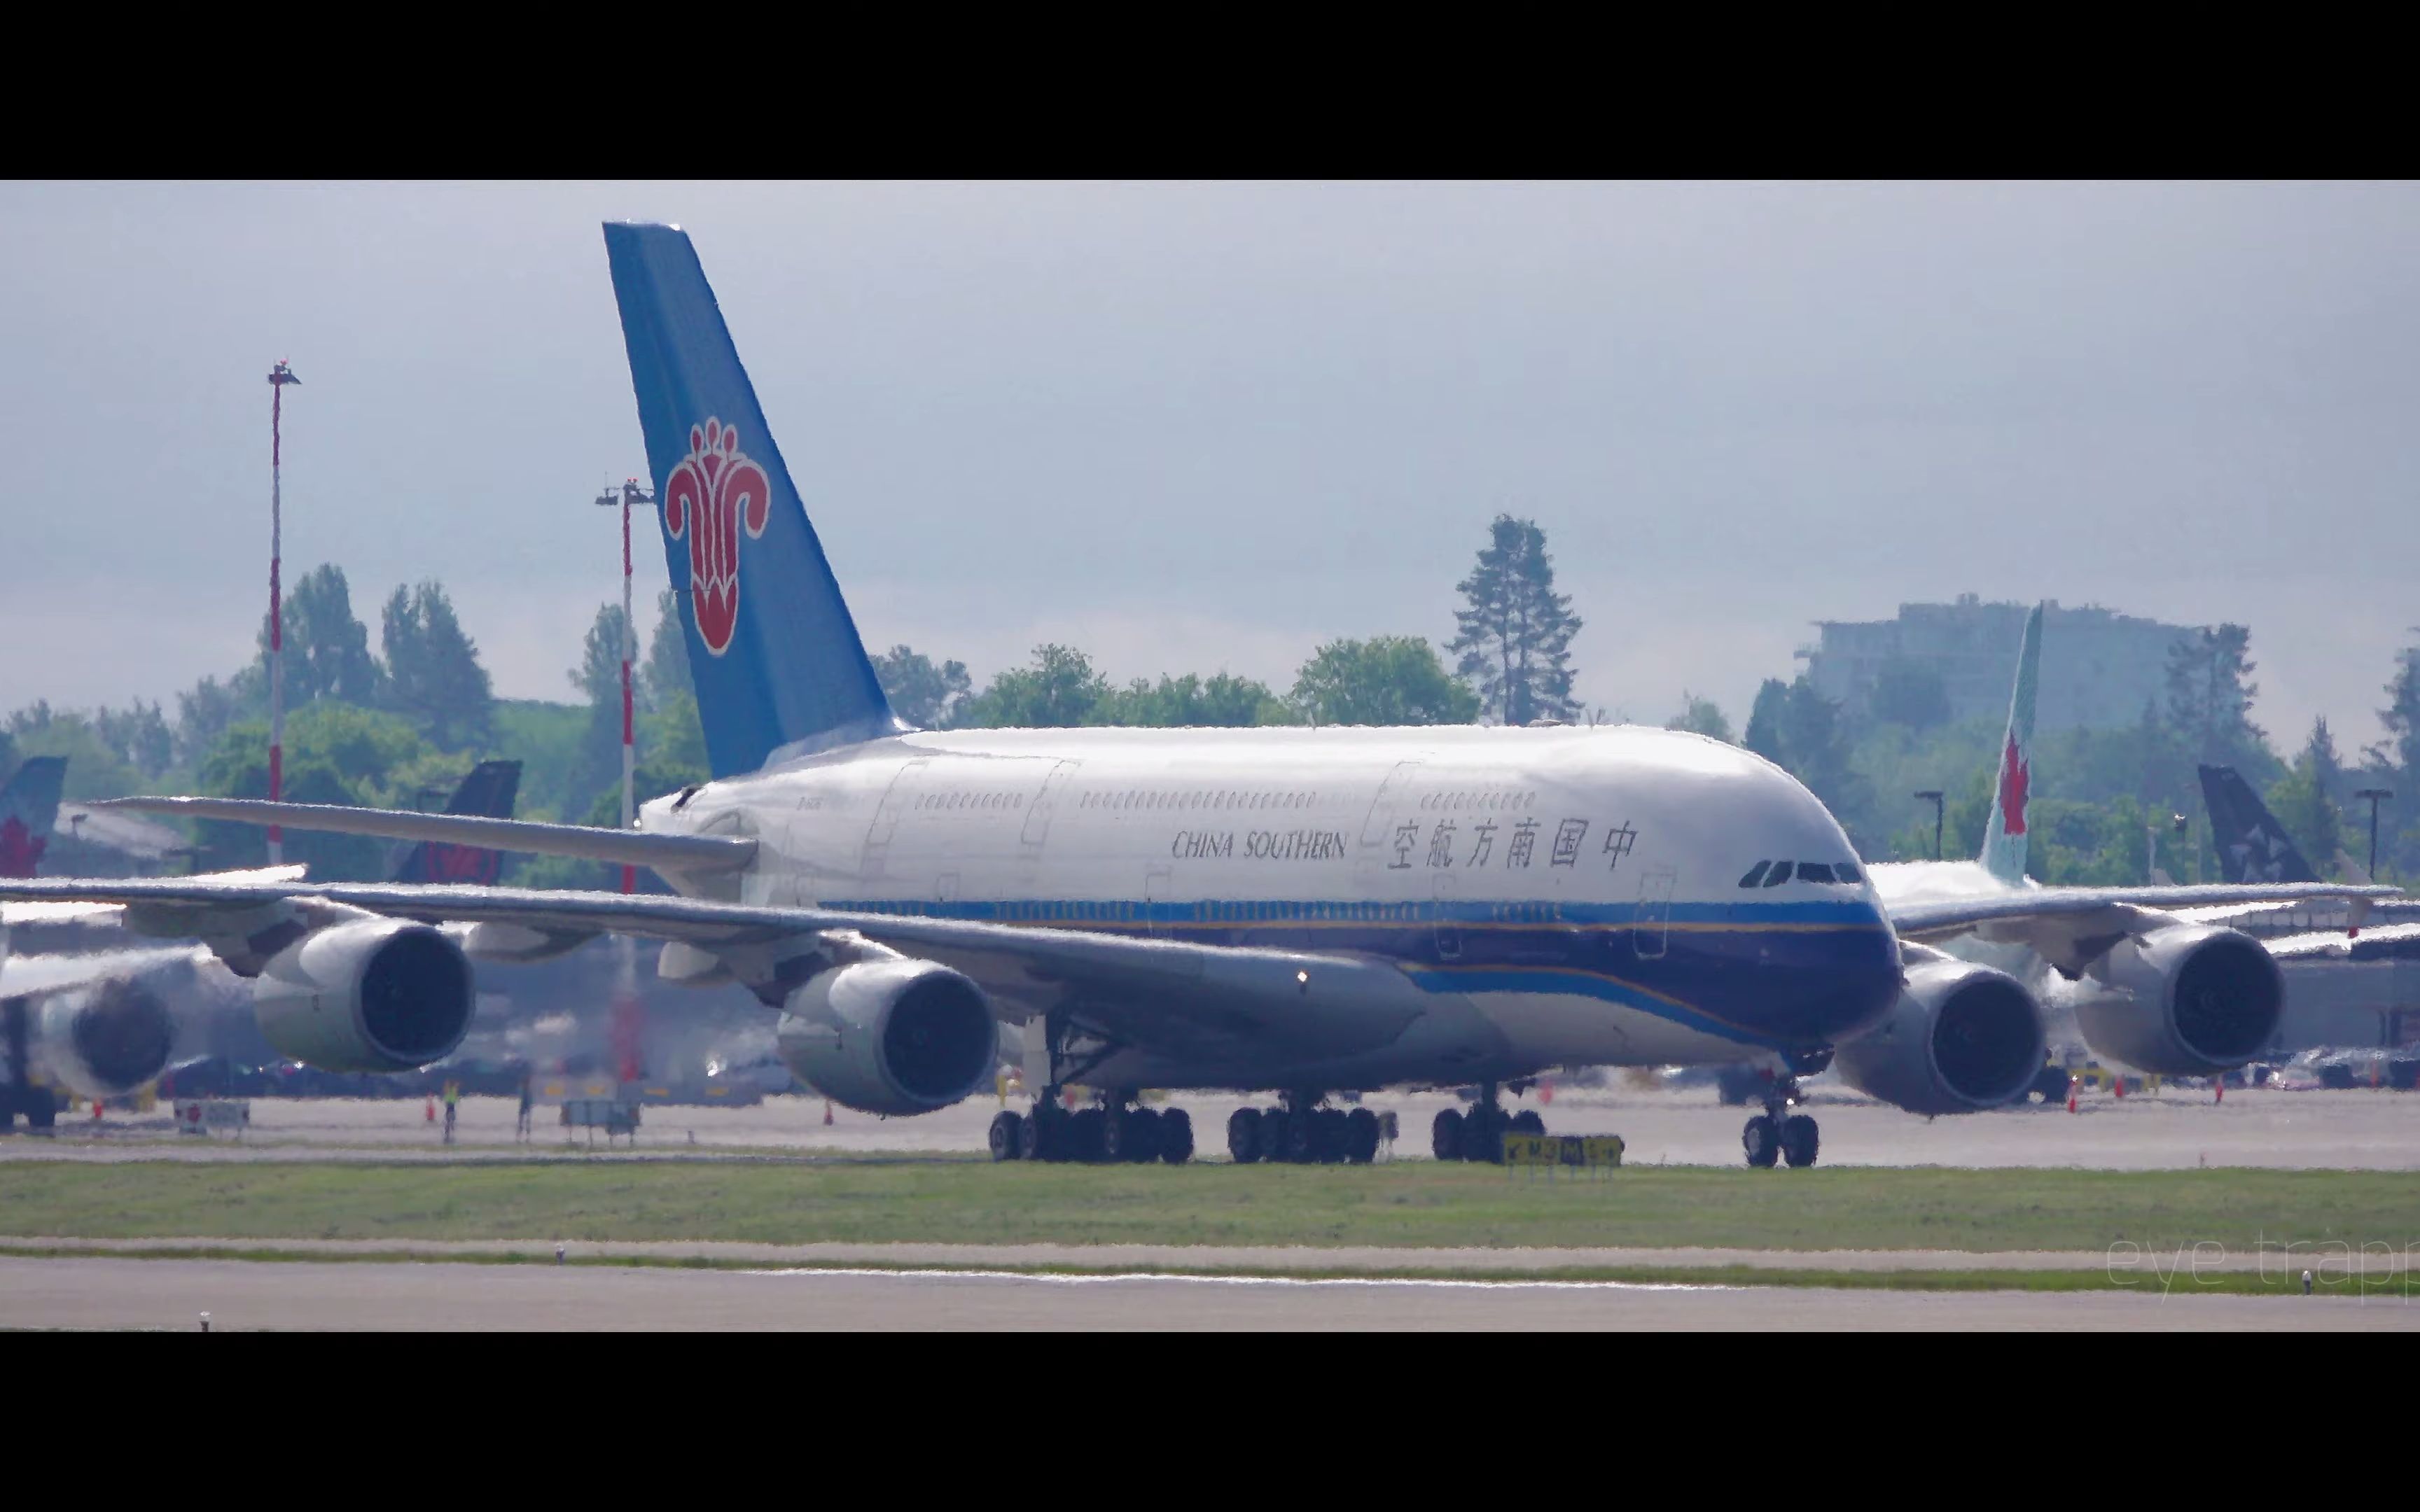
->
[0,1258,2420,1333]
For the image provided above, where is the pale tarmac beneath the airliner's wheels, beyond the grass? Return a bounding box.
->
[19,1086,2420,1171]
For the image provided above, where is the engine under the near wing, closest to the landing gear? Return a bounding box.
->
[777,958,999,1115]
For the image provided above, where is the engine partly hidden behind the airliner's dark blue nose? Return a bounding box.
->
[1832,946,2047,1113]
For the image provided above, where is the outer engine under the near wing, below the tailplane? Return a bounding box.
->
[251,919,477,1072]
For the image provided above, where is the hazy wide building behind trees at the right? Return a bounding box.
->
[1798,593,2197,731]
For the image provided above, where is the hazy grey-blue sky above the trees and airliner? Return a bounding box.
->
[0,184,2420,750]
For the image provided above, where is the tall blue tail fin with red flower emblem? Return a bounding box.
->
[605,223,905,776]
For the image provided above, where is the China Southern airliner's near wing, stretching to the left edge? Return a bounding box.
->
[0,871,1421,1055]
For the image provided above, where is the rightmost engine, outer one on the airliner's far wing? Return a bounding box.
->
[2076,924,2284,1077]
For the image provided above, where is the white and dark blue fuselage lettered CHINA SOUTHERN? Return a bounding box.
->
[639,726,1898,1082]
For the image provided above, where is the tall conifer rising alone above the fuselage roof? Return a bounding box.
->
[1447,515,1580,726]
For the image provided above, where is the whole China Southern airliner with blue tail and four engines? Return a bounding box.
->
[0,225,2381,1166]
